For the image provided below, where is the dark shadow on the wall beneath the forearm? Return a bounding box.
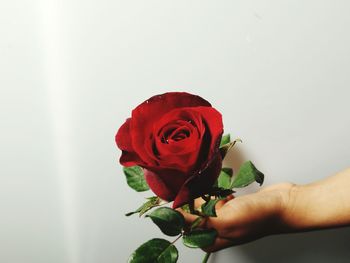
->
[216,227,350,263]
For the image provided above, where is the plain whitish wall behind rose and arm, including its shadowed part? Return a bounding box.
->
[0,0,350,263]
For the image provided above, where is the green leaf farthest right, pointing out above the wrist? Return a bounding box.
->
[231,161,264,188]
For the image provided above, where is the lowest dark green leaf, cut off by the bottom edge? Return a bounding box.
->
[128,238,178,263]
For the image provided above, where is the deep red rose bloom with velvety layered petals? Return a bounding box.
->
[115,92,223,208]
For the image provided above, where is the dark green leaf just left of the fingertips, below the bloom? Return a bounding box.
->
[146,207,185,236]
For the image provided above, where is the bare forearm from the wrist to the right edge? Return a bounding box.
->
[283,169,350,232]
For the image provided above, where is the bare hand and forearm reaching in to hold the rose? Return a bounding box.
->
[178,169,350,252]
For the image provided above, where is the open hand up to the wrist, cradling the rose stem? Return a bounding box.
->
[178,183,294,252]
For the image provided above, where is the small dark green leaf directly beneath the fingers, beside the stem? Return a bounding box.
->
[182,229,217,248]
